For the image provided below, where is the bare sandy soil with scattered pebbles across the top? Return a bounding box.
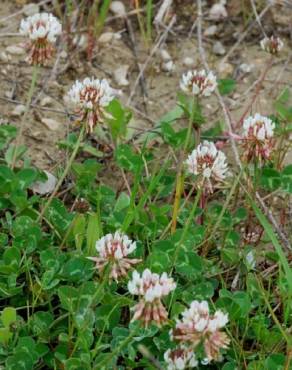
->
[0,0,292,170]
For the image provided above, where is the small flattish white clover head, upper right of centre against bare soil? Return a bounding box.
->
[180,70,217,96]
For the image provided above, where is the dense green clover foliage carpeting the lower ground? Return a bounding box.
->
[0,60,292,370]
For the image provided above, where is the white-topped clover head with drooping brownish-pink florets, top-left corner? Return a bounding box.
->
[19,13,62,65]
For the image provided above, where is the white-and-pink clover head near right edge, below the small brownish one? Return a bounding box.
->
[243,113,275,161]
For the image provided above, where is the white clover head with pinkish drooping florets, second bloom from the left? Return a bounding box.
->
[65,77,114,133]
